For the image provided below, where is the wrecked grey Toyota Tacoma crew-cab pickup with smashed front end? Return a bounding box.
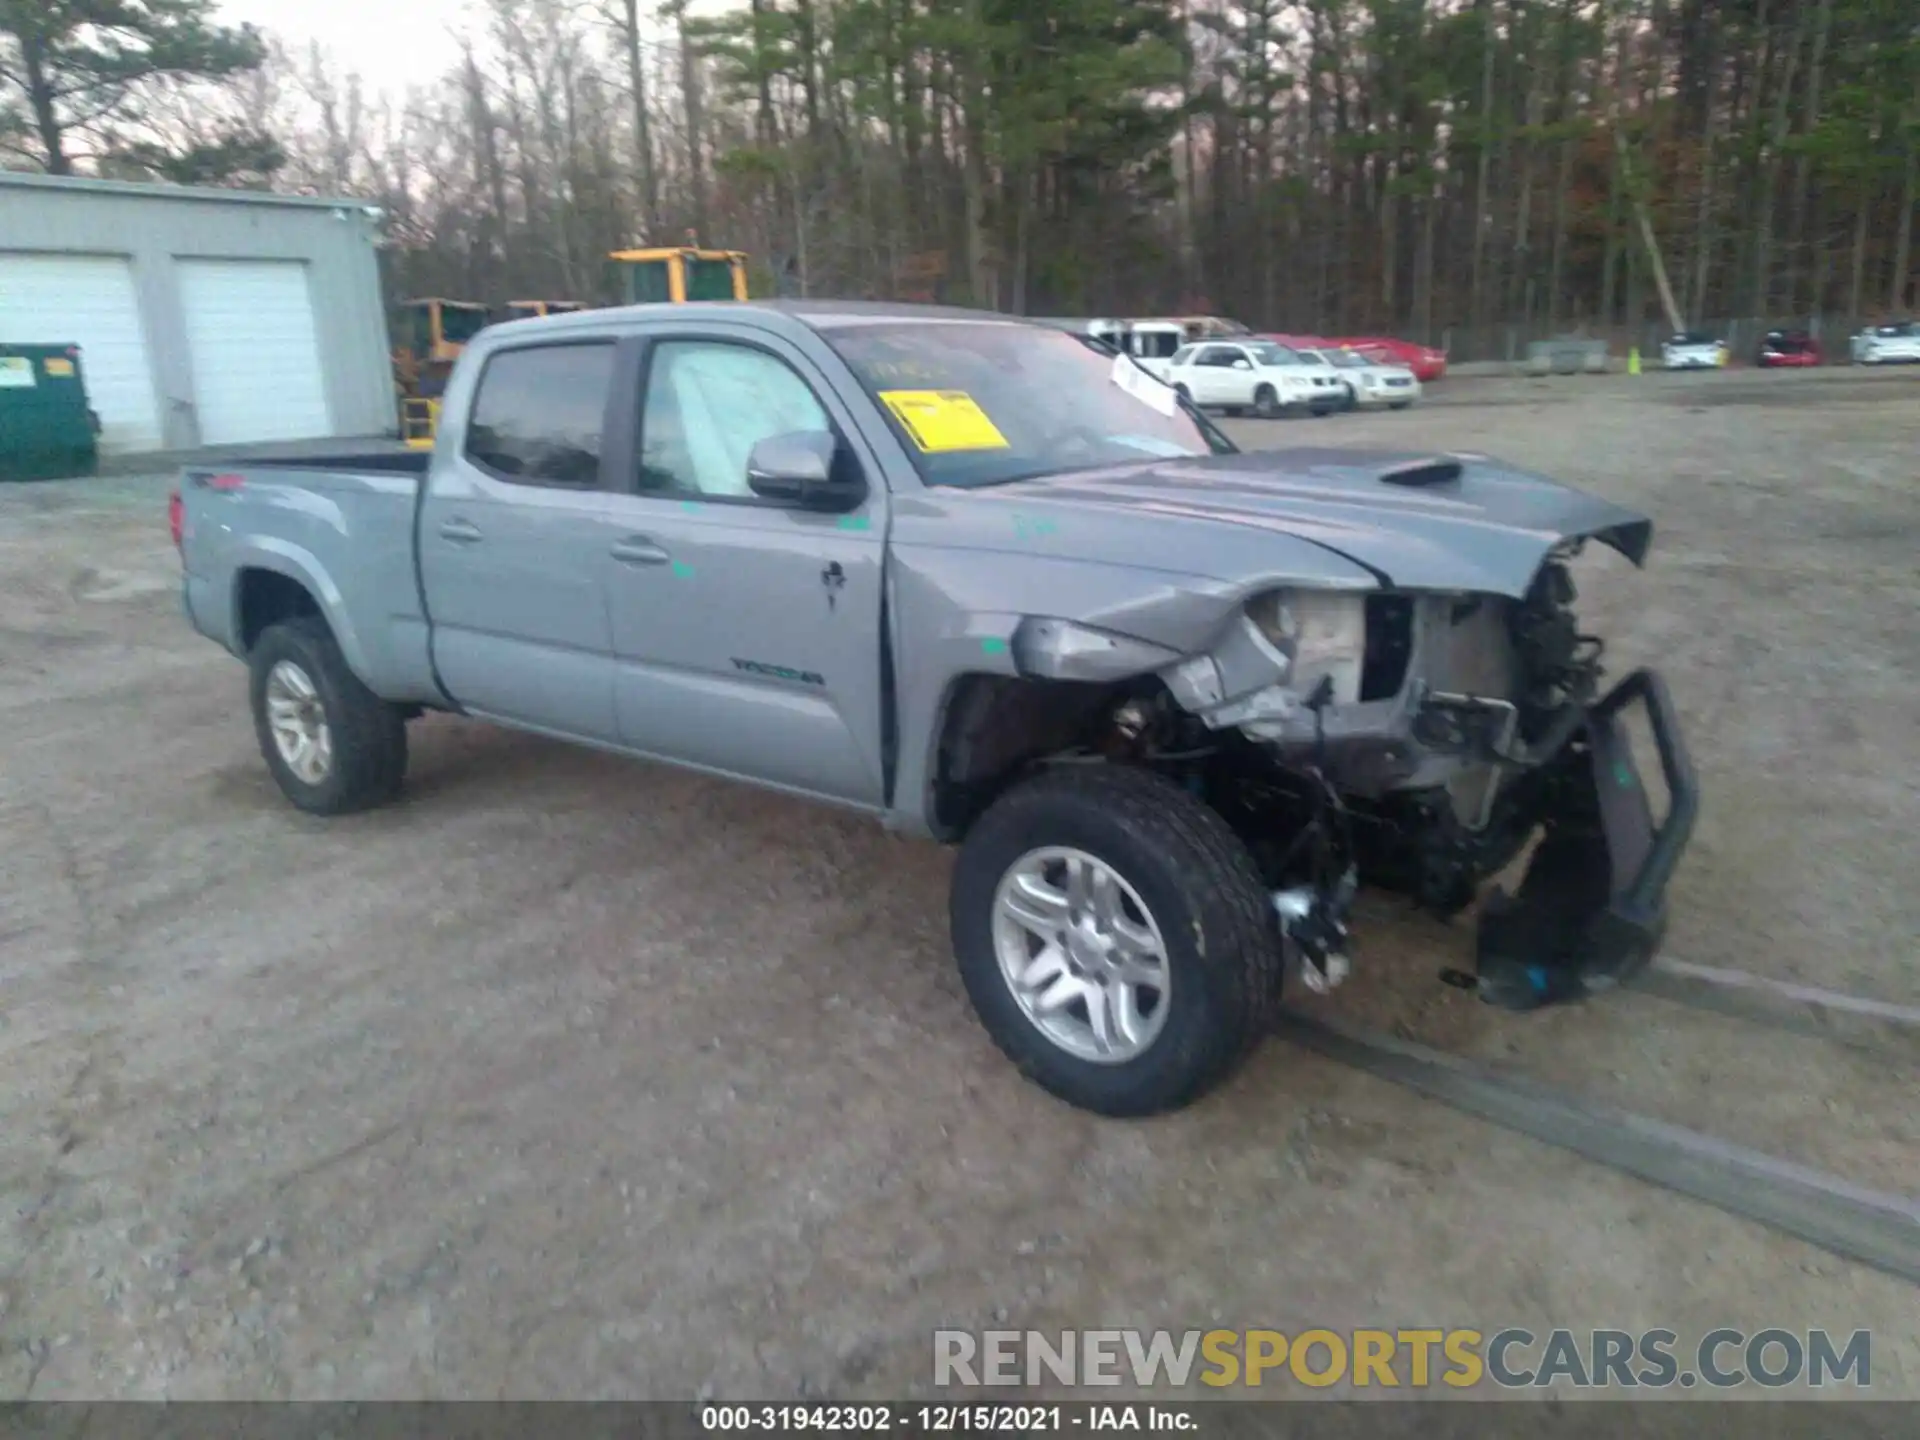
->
[173,303,1697,1116]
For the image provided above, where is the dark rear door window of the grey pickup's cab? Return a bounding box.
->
[467,342,614,486]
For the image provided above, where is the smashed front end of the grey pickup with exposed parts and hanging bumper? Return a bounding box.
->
[990,461,1699,1010]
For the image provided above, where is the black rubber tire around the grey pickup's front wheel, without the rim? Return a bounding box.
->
[948,764,1283,1116]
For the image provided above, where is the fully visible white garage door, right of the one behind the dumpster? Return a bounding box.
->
[175,259,332,445]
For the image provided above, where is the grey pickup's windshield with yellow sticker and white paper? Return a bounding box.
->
[822,321,1233,486]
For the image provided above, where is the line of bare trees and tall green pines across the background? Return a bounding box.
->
[0,0,1920,347]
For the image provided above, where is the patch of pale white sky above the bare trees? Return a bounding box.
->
[219,0,470,94]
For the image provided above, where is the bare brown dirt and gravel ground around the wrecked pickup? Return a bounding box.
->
[0,372,1920,1400]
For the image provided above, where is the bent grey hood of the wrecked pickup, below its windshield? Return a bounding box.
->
[973,447,1653,597]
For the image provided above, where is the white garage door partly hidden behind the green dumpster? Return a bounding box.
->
[0,253,159,449]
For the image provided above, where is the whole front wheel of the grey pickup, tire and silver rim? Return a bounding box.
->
[948,766,1281,1116]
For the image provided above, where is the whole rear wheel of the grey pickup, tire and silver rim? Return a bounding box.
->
[248,616,407,814]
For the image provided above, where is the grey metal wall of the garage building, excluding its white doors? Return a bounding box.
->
[0,173,397,449]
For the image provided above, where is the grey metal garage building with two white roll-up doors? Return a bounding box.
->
[0,173,397,451]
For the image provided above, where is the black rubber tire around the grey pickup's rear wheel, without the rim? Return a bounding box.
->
[248,616,407,814]
